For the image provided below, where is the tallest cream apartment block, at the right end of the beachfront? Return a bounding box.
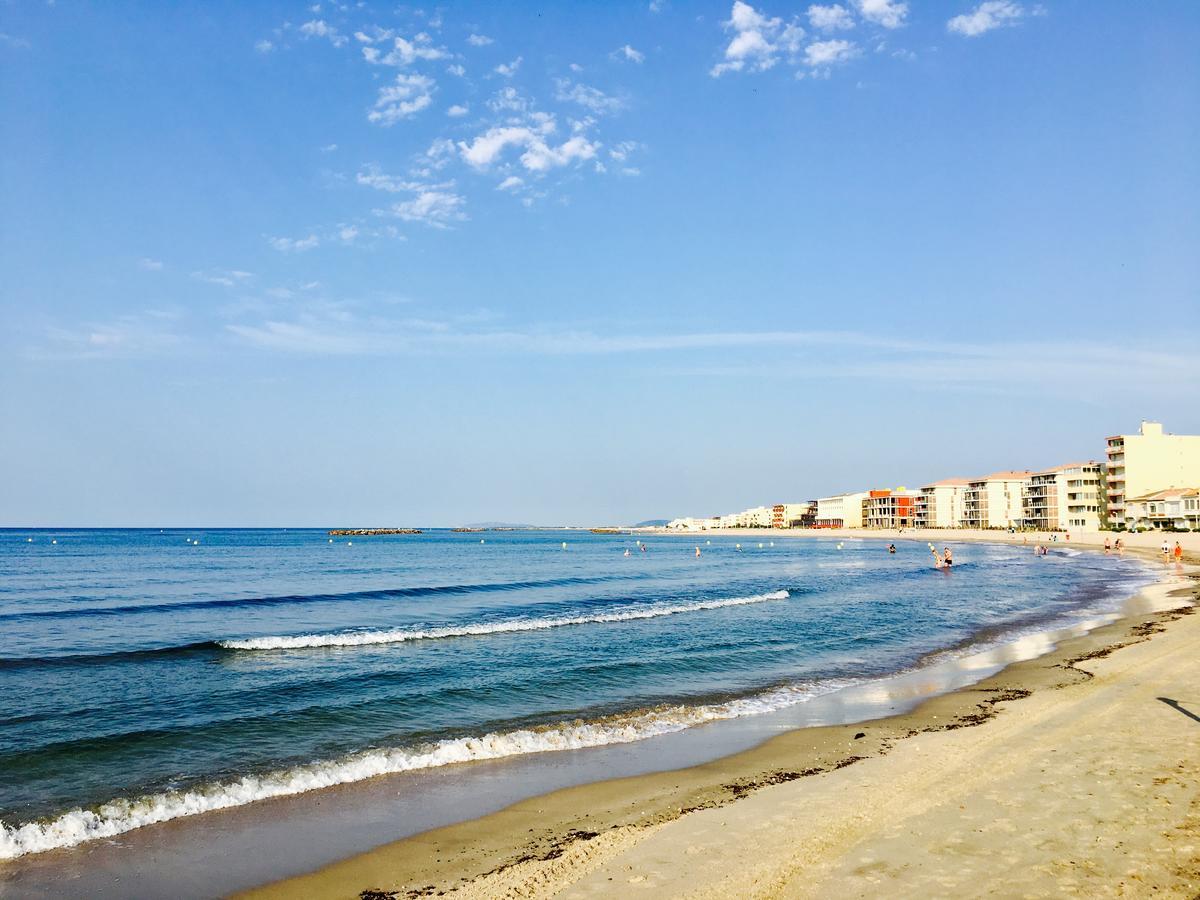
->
[1108,421,1200,528]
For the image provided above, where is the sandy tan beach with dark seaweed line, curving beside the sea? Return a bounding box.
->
[245,542,1200,898]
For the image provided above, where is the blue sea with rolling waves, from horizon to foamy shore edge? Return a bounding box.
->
[0,529,1147,859]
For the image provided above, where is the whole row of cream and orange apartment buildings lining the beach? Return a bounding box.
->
[667,421,1200,532]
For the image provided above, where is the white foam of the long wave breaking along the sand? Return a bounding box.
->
[0,680,848,859]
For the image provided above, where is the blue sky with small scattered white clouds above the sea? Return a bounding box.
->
[0,0,1200,527]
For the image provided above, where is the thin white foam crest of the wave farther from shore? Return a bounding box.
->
[217,590,790,650]
